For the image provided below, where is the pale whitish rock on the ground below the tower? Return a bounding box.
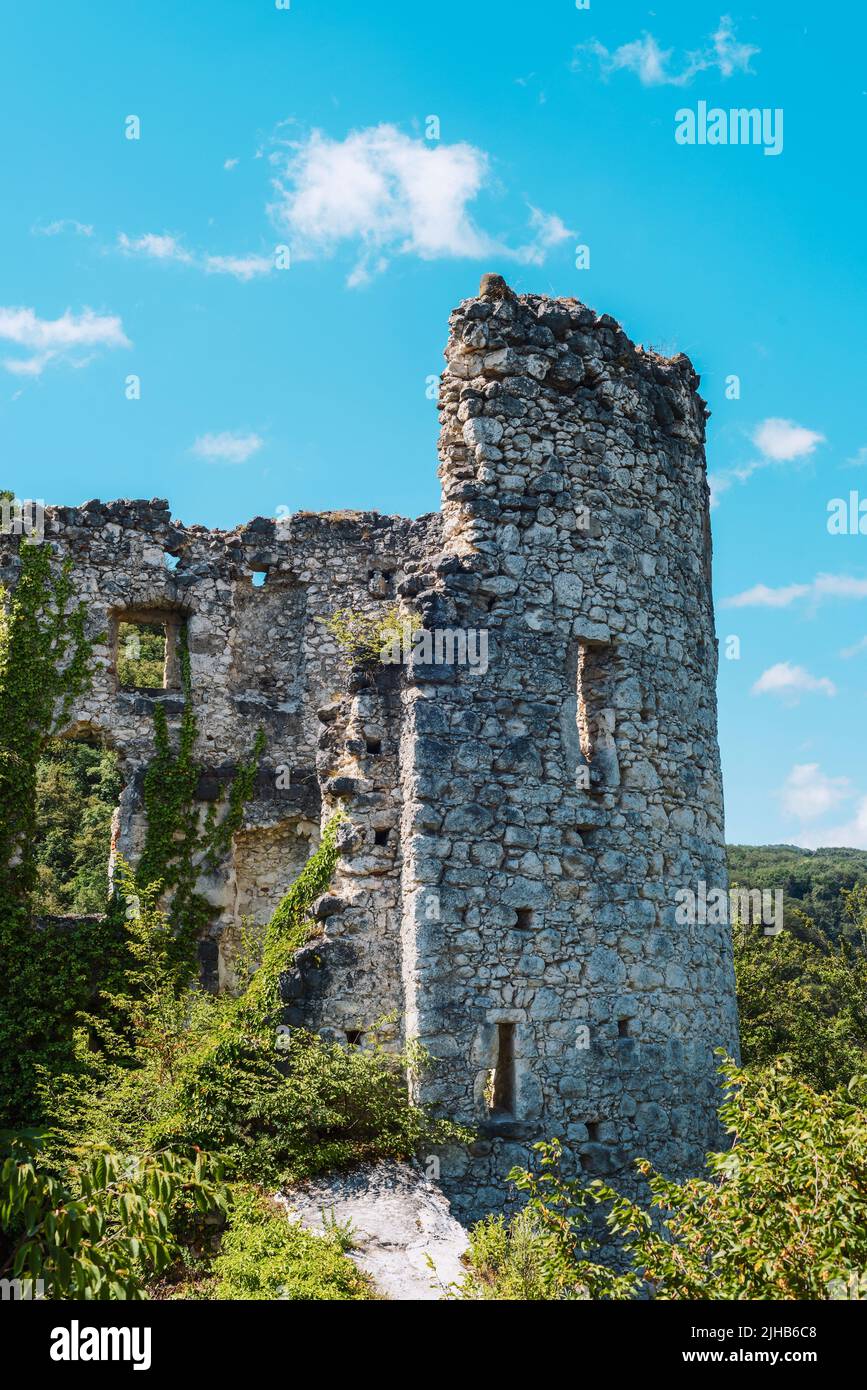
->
[281,1162,468,1300]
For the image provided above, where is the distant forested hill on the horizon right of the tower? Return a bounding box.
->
[727,845,867,941]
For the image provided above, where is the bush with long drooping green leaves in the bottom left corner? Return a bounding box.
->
[0,1134,228,1300]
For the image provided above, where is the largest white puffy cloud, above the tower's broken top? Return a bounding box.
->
[270,124,574,285]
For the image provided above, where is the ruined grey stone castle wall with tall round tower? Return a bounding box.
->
[3,275,736,1218]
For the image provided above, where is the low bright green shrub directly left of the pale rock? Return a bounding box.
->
[214,1188,371,1301]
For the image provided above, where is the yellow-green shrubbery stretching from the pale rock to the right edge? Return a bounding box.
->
[466,1062,867,1300]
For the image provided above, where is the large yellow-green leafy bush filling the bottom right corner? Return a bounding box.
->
[599,1062,867,1300]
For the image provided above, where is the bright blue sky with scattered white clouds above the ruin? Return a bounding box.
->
[0,0,867,847]
